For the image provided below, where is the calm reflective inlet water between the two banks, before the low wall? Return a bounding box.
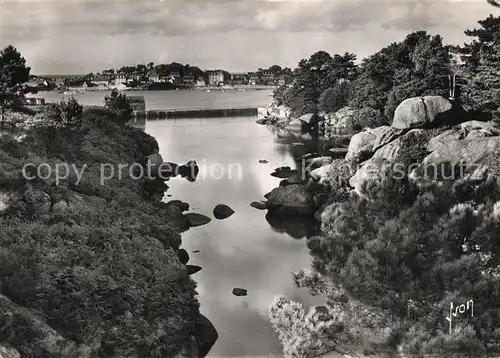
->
[145,117,322,357]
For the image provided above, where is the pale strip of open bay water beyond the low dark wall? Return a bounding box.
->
[37,90,272,110]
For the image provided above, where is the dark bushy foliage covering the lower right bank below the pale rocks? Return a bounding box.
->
[302,167,500,355]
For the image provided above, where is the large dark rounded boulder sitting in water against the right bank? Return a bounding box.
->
[267,185,316,215]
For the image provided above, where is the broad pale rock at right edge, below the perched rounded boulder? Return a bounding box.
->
[410,137,500,180]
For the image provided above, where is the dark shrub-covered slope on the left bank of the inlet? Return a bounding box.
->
[0,109,198,357]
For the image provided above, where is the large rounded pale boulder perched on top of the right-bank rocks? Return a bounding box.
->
[392,96,465,129]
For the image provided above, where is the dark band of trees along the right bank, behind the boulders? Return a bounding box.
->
[275,15,500,127]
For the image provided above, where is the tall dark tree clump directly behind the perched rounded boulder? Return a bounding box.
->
[350,31,450,120]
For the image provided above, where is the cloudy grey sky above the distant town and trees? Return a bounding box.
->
[0,0,500,75]
